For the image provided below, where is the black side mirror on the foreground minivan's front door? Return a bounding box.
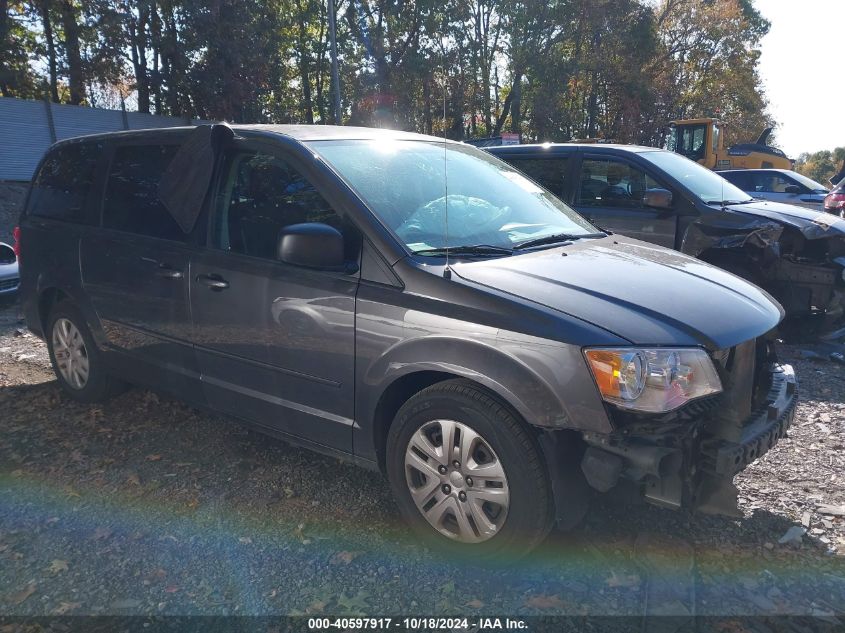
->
[276,222,344,270]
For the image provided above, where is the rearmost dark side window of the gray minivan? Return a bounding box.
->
[27,143,103,224]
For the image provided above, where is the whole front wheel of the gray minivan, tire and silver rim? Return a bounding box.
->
[387,380,554,559]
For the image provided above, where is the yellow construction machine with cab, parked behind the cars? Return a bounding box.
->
[666,119,794,171]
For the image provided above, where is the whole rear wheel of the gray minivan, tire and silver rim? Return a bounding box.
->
[46,302,126,402]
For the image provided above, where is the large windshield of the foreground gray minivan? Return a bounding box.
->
[309,139,599,254]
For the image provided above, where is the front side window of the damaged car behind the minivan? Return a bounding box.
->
[577,159,661,209]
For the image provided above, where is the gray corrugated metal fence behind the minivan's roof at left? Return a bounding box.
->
[0,97,202,181]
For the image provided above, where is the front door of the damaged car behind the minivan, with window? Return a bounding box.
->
[573,155,678,248]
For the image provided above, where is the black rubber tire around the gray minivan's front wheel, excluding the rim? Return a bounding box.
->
[386,380,554,560]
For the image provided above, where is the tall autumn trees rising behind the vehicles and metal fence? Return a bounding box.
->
[0,0,771,144]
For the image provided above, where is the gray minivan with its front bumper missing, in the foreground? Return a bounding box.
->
[18,125,796,557]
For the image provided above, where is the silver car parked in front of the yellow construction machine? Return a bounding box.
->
[719,169,830,211]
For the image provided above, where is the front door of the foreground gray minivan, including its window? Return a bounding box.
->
[191,142,358,452]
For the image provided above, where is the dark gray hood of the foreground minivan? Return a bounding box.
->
[452,236,783,350]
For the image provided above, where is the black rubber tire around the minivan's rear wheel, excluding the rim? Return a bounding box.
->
[45,301,127,403]
